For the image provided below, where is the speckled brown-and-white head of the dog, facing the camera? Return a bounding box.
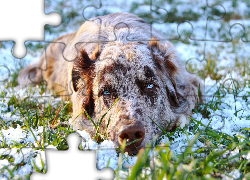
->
[71,39,200,154]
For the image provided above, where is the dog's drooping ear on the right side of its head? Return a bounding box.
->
[148,37,193,114]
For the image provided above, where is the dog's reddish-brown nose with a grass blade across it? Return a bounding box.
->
[118,125,145,154]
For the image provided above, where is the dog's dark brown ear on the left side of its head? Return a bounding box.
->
[72,49,94,92]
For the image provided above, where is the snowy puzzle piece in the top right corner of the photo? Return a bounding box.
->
[190,0,248,42]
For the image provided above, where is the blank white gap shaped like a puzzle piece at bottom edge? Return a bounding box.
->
[31,133,113,180]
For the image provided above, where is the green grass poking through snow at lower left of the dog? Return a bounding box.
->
[0,83,74,178]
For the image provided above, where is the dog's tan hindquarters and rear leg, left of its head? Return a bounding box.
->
[18,33,75,99]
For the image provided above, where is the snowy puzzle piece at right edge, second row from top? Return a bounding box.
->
[184,20,250,96]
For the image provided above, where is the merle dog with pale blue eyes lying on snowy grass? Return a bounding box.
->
[18,13,204,155]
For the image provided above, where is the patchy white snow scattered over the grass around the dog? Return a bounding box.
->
[0,0,250,180]
